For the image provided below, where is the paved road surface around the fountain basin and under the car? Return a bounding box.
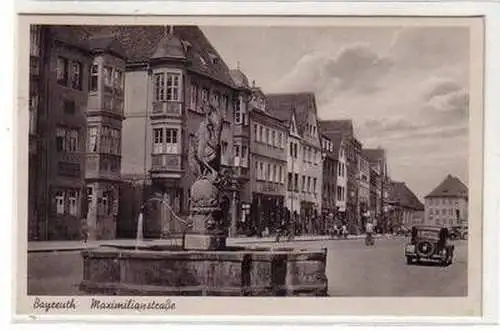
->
[28,238,467,296]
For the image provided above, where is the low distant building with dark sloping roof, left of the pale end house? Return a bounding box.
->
[388,182,424,229]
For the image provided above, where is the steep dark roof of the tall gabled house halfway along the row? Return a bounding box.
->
[266,92,316,135]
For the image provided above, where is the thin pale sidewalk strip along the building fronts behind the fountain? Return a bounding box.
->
[28,235,387,253]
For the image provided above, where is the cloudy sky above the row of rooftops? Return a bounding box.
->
[202,27,469,199]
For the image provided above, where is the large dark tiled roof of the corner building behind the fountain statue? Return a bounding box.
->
[84,25,234,86]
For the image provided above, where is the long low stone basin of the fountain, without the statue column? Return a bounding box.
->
[80,245,328,296]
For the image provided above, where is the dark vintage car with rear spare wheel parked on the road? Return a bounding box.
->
[405,225,455,266]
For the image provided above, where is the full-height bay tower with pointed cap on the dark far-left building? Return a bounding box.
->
[85,37,125,239]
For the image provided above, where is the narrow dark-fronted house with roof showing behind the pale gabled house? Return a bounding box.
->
[321,120,362,232]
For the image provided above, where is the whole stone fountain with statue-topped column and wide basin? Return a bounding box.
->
[80,106,327,296]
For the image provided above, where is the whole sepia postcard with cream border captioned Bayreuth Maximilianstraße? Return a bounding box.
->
[15,15,484,318]
